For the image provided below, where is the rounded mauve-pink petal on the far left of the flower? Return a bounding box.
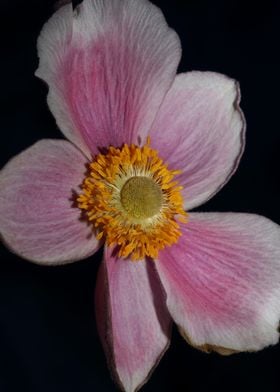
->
[0,140,98,264]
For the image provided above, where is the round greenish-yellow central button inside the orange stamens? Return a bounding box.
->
[121,176,163,219]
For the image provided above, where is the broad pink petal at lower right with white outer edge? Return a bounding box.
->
[156,213,280,353]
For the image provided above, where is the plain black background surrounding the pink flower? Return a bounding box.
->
[0,0,280,392]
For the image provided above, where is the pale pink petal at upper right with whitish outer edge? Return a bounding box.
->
[151,72,245,210]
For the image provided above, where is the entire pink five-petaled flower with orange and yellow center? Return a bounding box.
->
[0,0,280,392]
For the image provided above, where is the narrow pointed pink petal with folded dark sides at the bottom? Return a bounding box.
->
[96,248,171,392]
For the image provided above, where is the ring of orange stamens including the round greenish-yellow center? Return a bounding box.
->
[77,139,187,260]
